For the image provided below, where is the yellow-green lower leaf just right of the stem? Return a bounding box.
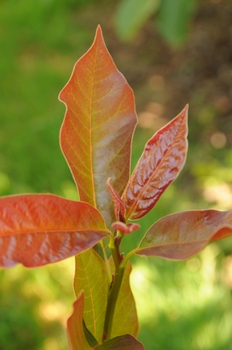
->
[111,260,139,338]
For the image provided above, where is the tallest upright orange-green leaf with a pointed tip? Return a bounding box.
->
[60,27,137,227]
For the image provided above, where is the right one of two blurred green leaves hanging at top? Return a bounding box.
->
[157,0,195,45]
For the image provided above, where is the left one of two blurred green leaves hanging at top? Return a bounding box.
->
[116,0,160,41]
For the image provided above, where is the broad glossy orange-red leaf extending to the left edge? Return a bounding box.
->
[0,194,108,267]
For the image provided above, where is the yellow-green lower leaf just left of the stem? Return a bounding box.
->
[74,249,109,342]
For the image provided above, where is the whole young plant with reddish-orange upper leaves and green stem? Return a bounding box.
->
[0,27,232,350]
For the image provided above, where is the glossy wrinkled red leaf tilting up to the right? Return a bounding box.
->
[122,106,188,220]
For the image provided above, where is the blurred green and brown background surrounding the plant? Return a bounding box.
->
[0,0,232,350]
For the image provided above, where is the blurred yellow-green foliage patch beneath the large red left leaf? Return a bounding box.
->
[0,258,74,350]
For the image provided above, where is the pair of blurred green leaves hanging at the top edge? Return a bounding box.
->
[115,0,196,46]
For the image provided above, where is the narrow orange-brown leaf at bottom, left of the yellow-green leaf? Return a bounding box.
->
[67,292,93,350]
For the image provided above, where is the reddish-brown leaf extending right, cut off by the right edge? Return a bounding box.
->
[137,210,232,260]
